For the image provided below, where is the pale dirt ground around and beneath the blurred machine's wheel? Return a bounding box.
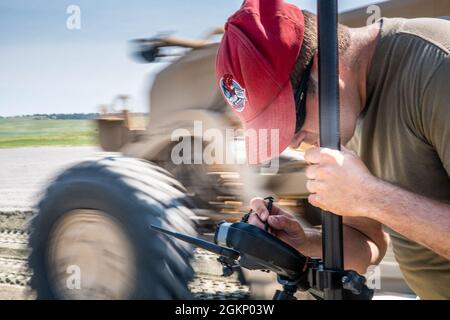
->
[0,147,413,299]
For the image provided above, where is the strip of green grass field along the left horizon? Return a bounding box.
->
[0,117,96,148]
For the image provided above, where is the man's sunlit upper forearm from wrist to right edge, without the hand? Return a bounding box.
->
[362,180,450,259]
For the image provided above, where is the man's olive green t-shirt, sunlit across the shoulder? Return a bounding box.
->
[348,18,450,299]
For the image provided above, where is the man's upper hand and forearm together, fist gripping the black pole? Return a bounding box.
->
[305,148,450,259]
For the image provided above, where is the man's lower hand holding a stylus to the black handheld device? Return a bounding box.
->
[248,198,308,252]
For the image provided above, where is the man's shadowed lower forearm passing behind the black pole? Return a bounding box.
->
[298,225,384,274]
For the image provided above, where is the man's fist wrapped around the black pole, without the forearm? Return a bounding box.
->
[305,147,377,217]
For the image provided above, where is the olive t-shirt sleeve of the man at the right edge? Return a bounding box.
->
[422,56,450,177]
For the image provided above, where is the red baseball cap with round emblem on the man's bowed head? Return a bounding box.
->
[216,0,304,164]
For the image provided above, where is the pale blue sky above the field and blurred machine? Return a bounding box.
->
[0,0,384,116]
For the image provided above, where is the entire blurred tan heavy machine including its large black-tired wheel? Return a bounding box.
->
[29,0,450,299]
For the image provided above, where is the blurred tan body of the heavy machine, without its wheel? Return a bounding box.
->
[98,29,307,225]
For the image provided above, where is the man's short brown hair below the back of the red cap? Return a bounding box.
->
[291,10,351,90]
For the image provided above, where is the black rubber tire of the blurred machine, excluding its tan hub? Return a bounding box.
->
[29,154,196,299]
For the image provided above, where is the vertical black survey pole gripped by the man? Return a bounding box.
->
[317,0,344,300]
